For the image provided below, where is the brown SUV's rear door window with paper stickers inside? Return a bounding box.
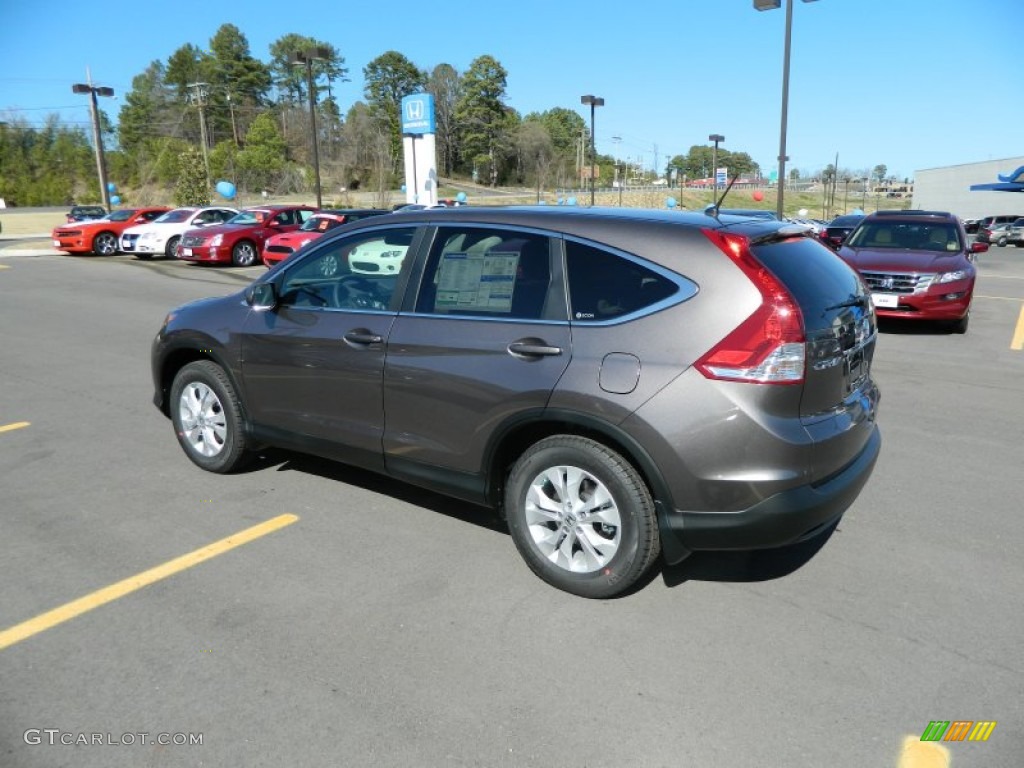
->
[416,226,564,319]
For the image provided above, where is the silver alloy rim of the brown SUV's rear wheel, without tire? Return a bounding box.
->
[525,466,623,573]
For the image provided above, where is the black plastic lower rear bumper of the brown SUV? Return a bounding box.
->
[662,427,882,551]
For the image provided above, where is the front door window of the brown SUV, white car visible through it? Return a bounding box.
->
[279,227,416,310]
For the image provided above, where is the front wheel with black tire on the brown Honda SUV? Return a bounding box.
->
[170,360,249,474]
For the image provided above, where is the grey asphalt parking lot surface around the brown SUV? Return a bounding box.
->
[0,249,1024,768]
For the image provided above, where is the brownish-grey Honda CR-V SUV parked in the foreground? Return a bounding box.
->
[153,206,881,597]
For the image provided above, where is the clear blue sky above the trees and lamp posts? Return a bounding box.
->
[0,0,1024,180]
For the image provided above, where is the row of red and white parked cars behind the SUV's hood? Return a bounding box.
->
[52,205,388,266]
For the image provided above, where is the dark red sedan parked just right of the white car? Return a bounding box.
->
[175,205,316,266]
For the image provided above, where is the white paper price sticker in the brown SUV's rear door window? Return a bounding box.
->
[434,251,519,312]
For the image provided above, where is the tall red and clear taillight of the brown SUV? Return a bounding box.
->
[695,229,806,384]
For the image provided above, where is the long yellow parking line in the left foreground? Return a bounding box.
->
[0,515,299,650]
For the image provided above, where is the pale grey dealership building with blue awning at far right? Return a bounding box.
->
[911,157,1024,219]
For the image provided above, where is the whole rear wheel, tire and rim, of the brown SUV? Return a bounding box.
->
[505,435,660,599]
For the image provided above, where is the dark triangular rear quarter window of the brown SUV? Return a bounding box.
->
[565,241,679,323]
